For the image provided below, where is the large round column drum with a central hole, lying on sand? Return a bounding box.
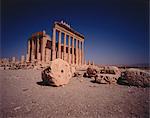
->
[42,58,72,86]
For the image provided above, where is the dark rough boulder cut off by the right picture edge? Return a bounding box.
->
[122,68,150,87]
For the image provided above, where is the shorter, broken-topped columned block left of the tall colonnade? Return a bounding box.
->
[26,31,51,62]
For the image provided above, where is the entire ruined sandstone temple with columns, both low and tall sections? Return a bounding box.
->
[26,21,85,65]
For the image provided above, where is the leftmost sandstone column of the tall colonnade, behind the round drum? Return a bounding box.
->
[52,28,56,61]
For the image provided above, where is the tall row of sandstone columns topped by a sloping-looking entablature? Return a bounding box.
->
[52,24,84,65]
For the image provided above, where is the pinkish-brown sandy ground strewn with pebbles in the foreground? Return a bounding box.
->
[0,70,150,118]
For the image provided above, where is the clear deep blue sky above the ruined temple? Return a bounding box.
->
[1,0,149,64]
